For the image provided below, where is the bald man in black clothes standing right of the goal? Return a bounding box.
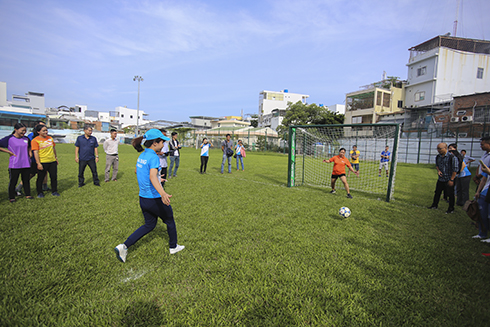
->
[429,143,459,214]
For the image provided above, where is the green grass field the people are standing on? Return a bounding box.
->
[0,144,490,326]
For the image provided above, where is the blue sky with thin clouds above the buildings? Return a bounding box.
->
[0,0,490,122]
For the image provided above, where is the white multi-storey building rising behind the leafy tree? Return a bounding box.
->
[259,90,310,130]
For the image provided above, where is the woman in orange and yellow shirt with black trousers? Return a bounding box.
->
[31,125,60,198]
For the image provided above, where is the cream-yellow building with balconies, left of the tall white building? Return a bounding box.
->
[344,78,405,124]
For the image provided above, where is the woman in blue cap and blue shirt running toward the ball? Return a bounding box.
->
[114,129,184,262]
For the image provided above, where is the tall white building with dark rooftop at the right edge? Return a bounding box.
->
[405,36,490,108]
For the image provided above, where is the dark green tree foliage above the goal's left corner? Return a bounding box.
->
[277,101,344,134]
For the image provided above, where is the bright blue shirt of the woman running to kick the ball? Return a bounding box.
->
[136,149,161,199]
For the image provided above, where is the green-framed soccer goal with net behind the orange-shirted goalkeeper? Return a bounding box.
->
[288,124,400,201]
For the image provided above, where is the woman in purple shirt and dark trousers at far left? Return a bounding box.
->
[0,123,32,202]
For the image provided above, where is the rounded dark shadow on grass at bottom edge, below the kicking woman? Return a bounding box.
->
[121,301,167,326]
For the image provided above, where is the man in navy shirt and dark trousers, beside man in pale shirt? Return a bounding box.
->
[75,125,100,187]
